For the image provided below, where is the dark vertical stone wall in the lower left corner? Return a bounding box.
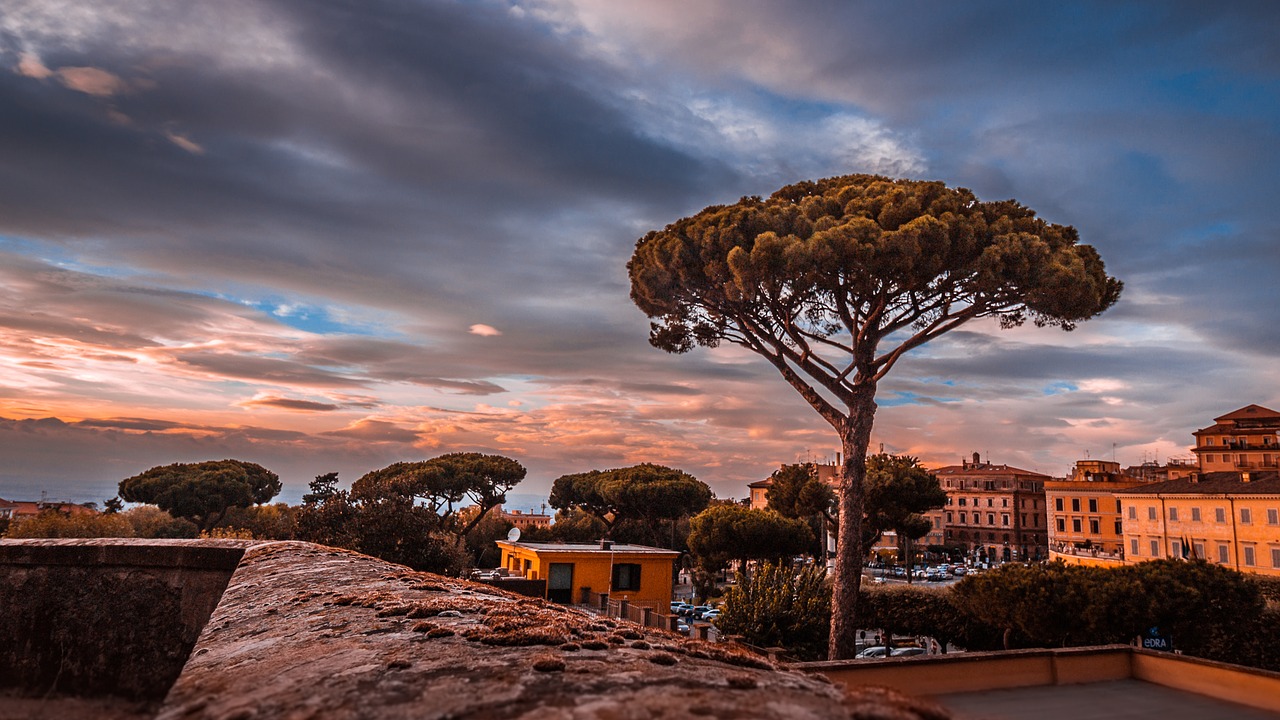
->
[0,539,244,700]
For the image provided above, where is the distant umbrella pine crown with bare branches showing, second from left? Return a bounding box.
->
[350,452,526,537]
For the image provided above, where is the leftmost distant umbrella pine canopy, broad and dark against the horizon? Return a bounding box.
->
[120,460,280,530]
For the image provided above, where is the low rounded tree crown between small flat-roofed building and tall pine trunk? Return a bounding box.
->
[689,503,814,571]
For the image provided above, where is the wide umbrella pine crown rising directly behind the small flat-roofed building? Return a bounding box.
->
[548,462,712,550]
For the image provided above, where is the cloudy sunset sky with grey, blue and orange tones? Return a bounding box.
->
[0,0,1280,505]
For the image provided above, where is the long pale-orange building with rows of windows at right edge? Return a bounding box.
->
[1117,470,1280,575]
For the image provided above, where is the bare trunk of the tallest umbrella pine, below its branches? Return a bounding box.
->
[827,386,876,660]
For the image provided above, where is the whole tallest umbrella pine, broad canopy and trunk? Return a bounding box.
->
[627,176,1123,660]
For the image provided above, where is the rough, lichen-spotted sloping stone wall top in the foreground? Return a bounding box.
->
[159,543,946,720]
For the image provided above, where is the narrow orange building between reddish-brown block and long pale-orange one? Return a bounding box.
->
[1044,460,1149,566]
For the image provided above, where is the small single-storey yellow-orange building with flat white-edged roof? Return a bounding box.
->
[498,541,680,604]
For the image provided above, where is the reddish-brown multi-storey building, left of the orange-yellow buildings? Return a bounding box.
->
[933,452,1052,562]
